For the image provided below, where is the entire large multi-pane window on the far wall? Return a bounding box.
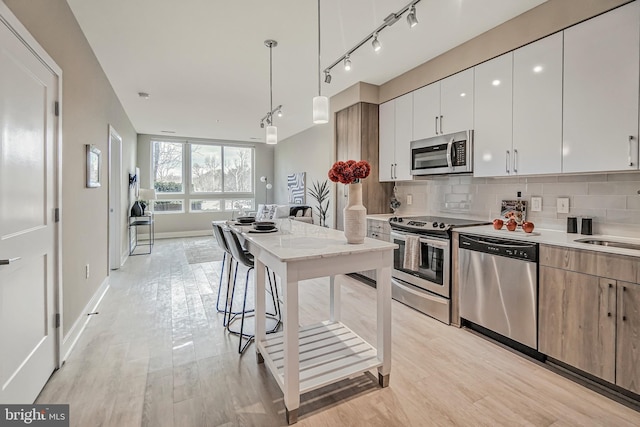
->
[151,141,255,213]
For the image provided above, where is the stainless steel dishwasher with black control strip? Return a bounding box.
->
[458,235,538,350]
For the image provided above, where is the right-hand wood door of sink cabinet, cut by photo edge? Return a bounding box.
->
[616,282,640,394]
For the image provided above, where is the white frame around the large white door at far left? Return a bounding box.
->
[0,0,64,369]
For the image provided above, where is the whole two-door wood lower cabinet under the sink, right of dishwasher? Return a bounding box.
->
[538,245,640,394]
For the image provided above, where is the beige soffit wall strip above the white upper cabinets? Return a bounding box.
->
[379,0,631,103]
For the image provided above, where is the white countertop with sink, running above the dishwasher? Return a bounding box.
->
[454,225,640,258]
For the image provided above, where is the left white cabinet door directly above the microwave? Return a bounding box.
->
[413,82,441,139]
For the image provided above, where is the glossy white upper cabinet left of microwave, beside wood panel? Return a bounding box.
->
[379,93,413,182]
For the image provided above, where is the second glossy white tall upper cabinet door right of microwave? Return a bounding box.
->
[511,33,562,175]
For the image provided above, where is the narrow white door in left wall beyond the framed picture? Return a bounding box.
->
[107,125,122,270]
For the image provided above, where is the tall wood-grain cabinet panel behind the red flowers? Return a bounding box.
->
[335,102,393,230]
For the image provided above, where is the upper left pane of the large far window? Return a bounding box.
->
[151,141,184,193]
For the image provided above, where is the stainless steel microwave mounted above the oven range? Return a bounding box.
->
[411,130,473,175]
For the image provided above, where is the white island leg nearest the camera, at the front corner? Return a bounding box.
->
[281,272,300,424]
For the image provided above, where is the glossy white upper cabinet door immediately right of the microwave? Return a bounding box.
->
[473,52,514,176]
